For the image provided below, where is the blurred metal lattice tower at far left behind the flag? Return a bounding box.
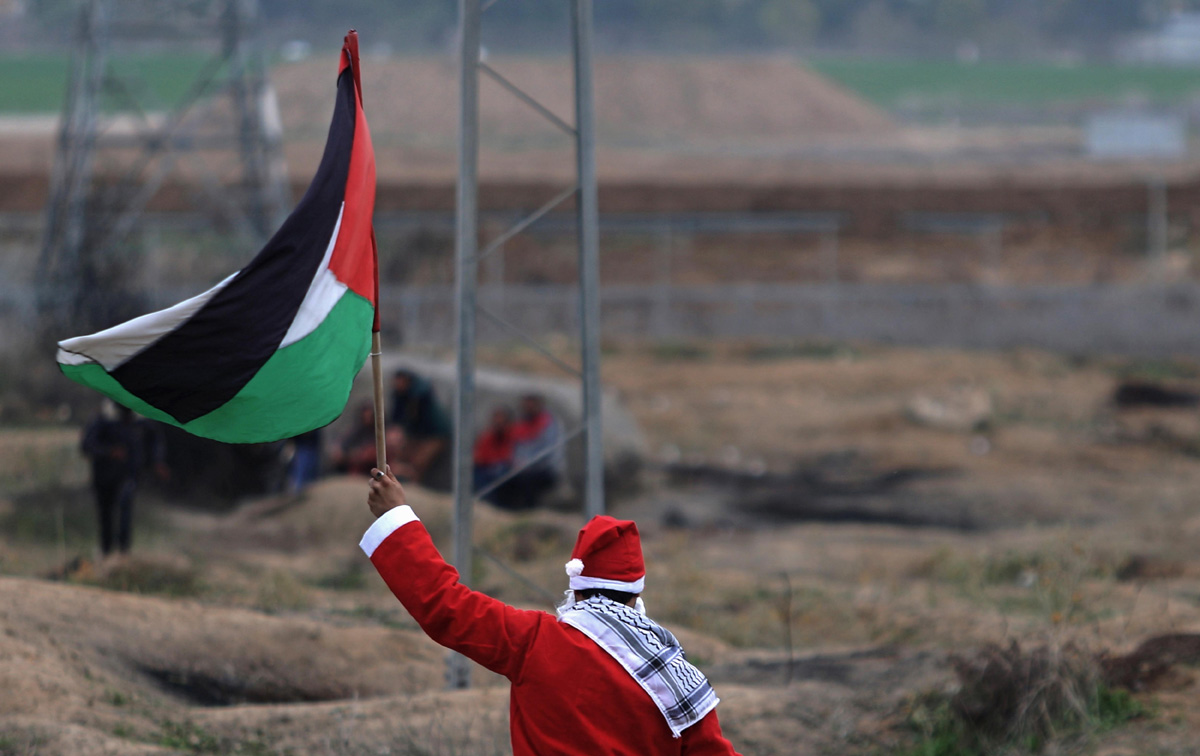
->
[38,0,289,330]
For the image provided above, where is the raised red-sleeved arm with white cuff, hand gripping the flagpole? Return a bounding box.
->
[359,470,544,680]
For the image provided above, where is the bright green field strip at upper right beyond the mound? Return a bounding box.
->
[809,59,1200,109]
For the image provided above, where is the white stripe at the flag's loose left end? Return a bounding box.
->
[58,274,238,372]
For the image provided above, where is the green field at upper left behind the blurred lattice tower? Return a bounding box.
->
[0,54,220,114]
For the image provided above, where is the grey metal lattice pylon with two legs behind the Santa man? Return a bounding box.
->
[448,0,605,688]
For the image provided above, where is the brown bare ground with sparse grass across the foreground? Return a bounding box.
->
[0,344,1200,756]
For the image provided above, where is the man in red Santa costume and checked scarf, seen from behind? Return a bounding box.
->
[359,469,737,756]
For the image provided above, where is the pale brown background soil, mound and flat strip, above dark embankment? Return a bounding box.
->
[0,56,1195,188]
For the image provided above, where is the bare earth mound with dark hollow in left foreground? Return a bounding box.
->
[0,578,442,714]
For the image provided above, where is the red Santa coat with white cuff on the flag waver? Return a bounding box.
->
[360,505,737,756]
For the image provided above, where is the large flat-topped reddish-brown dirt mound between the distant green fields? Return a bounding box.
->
[271,58,894,150]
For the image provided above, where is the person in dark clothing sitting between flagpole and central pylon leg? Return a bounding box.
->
[389,370,451,482]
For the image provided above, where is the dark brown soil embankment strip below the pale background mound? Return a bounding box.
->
[7,169,1200,238]
